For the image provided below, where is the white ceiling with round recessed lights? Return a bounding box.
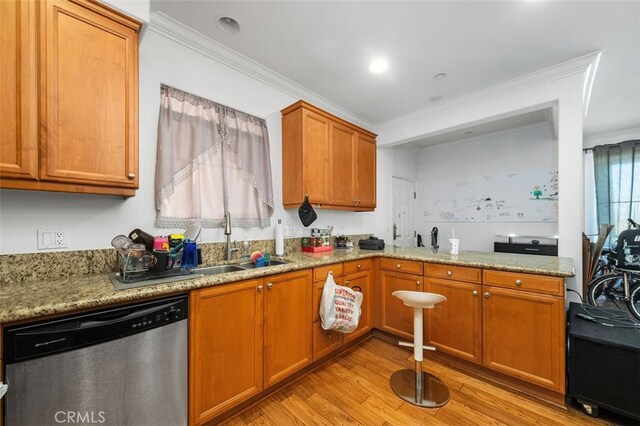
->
[151,0,640,134]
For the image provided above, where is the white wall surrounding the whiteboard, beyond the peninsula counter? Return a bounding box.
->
[418,124,558,251]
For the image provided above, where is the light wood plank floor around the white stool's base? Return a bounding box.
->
[225,338,620,426]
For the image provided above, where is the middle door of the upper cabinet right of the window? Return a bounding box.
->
[331,123,357,206]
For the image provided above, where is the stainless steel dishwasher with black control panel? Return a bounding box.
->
[3,296,188,426]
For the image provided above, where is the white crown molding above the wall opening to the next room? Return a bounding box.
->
[374,51,601,134]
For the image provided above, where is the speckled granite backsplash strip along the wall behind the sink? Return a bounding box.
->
[0,234,370,285]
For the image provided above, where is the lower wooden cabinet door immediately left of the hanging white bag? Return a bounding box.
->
[264,270,312,387]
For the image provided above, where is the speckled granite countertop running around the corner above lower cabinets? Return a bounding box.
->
[0,247,574,323]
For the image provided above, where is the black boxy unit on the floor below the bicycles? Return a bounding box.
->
[567,302,640,420]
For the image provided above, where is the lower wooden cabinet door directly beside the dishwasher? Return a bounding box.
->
[189,280,264,424]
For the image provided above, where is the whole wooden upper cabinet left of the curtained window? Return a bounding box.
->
[0,0,141,196]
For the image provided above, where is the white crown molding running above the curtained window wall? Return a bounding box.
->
[149,11,374,129]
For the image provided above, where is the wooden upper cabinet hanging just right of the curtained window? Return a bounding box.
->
[282,101,376,211]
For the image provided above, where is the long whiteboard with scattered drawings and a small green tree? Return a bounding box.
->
[421,170,558,222]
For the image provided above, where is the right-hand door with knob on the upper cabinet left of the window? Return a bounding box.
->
[40,0,138,188]
